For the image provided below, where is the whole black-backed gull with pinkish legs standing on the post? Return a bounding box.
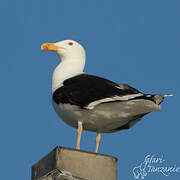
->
[41,40,171,152]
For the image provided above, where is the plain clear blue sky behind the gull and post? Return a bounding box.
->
[0,0,180,180]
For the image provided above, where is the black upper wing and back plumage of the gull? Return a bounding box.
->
[53,74,141,108]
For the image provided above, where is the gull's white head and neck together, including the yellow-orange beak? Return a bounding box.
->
[41,40,86,92]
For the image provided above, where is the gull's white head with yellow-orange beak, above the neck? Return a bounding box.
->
[41,40,86,61]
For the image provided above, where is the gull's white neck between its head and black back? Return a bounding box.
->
[52,58,85,93]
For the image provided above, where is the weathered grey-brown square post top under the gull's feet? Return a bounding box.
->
[32,147,117,180]
